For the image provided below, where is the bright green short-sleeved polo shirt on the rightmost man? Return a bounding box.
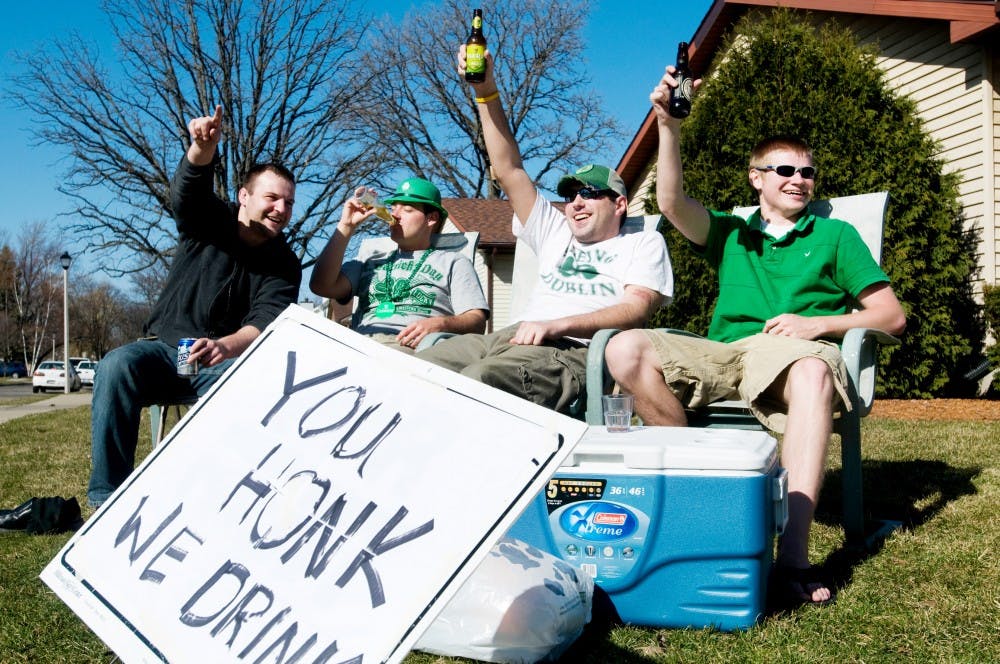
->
[694,210,889,342]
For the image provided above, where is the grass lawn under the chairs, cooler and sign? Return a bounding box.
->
[0,408,1000,664]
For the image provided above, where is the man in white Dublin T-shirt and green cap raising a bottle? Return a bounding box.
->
[417,46,673,412]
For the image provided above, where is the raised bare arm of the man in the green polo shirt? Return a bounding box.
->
[649,66,709,246]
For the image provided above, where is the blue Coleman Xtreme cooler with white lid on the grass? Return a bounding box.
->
[508,426,788,630]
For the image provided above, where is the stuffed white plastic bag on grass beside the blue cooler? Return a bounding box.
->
[416,537,594,664]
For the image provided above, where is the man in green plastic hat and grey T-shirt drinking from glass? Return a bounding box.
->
[309,177,489,353]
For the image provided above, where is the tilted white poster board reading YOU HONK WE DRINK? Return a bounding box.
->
[42,306,586,664]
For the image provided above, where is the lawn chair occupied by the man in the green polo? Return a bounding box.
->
[587,192,899,544]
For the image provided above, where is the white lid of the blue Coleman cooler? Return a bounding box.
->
[563,426,777,473]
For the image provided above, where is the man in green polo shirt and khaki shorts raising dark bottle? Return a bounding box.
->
[605,67,906,604]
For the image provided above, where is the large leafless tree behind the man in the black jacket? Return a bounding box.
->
[10,0,383,276]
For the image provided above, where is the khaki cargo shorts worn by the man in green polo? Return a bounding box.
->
[643,330,851,433]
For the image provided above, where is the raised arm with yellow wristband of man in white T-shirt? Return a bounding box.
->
[458,44,538,222]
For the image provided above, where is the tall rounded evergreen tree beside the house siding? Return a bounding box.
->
[654,9,984,397]
